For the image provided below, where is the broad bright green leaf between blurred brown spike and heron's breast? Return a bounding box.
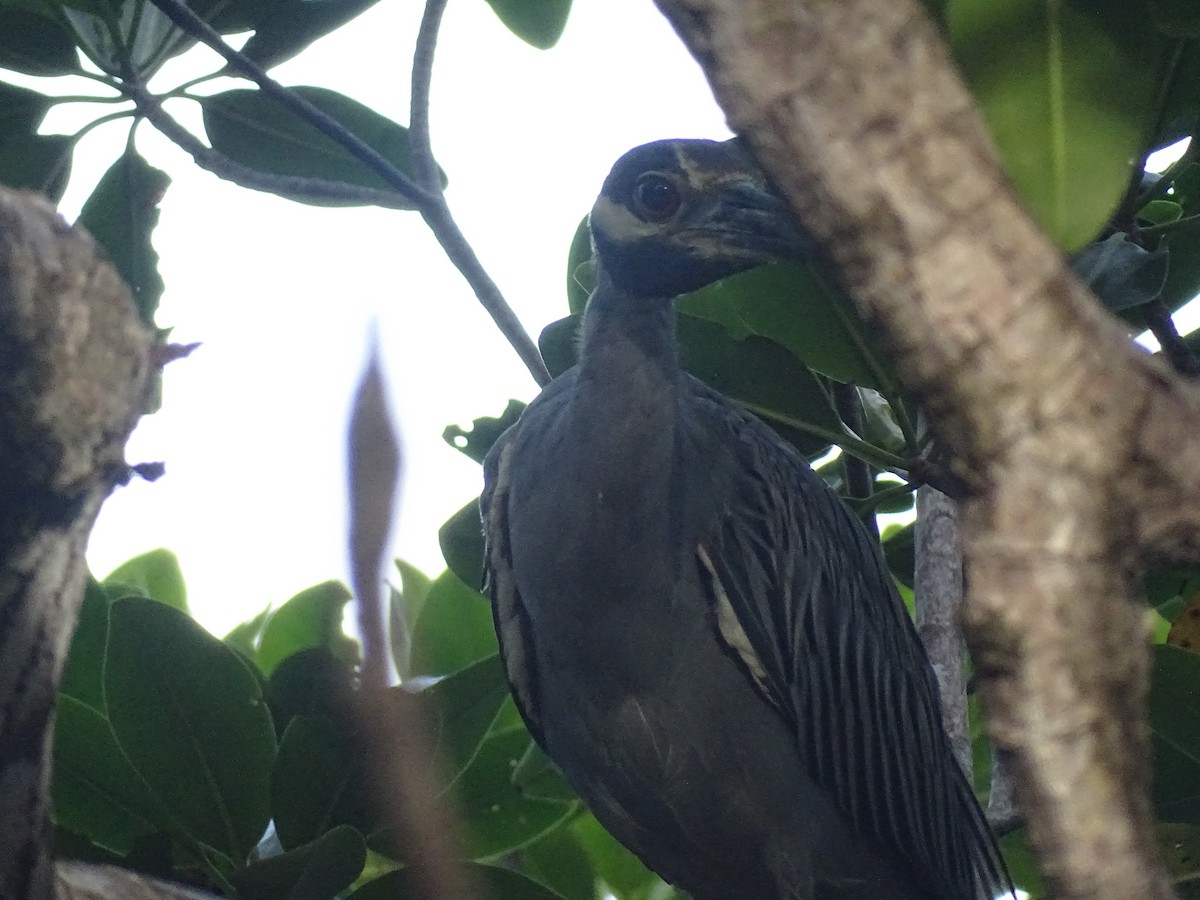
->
[409,571,497,676]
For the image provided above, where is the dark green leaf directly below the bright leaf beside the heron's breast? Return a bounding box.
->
[420,655,509,780]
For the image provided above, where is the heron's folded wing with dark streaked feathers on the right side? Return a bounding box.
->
[697,405,1008,898]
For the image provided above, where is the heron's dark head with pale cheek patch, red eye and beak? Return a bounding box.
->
[590,138,811,298]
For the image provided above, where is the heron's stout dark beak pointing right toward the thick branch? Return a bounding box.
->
[702,181,815,263]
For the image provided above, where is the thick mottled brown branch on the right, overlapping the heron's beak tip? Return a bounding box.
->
[656,0,1200,900]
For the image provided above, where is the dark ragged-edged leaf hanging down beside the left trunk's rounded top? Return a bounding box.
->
[78,150,170,325]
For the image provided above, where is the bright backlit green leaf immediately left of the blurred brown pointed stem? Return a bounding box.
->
[257,581,359,676]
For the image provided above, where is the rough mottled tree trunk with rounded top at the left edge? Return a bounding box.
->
[0,188,216,900]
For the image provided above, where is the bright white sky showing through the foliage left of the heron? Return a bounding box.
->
[24,0,728,634]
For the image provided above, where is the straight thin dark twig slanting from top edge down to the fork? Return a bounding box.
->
[150,0,431,205]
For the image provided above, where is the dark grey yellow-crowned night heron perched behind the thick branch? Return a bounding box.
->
[481,140,1008,900]
